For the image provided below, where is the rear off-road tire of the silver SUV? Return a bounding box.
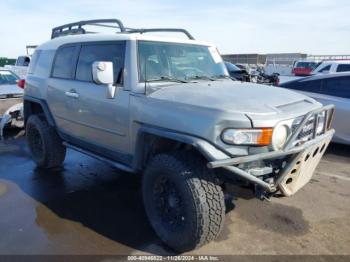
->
[26,115,66,168]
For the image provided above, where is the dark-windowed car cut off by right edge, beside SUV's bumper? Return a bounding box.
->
[280,72,350,145]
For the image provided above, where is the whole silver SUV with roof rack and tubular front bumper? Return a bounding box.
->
[24,19,334,251]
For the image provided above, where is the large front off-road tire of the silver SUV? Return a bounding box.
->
[142,152,225,252]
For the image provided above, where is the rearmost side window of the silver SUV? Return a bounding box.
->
[52,46,76,79]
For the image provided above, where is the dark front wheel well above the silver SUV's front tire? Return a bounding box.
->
[135,134,204,169]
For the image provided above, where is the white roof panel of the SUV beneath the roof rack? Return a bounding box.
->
[37,33,213,50]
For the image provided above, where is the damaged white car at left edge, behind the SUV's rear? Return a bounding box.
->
[0,68,23,138]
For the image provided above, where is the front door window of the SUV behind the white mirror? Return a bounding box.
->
[75,42,125,84]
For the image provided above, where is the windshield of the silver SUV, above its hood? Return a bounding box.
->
[138,41,228,82]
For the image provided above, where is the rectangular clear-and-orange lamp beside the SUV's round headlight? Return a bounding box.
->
[221,128,272,146]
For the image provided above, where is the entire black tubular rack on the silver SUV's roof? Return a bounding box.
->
[51,19,194,40]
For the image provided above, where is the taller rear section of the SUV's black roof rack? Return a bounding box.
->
[51,19,125,39]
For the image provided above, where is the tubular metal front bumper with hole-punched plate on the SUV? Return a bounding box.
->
[208,105,335,196]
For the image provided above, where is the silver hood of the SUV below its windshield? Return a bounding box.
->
[149,80,320,118]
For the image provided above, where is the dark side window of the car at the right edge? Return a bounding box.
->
[322,76,350,98]
